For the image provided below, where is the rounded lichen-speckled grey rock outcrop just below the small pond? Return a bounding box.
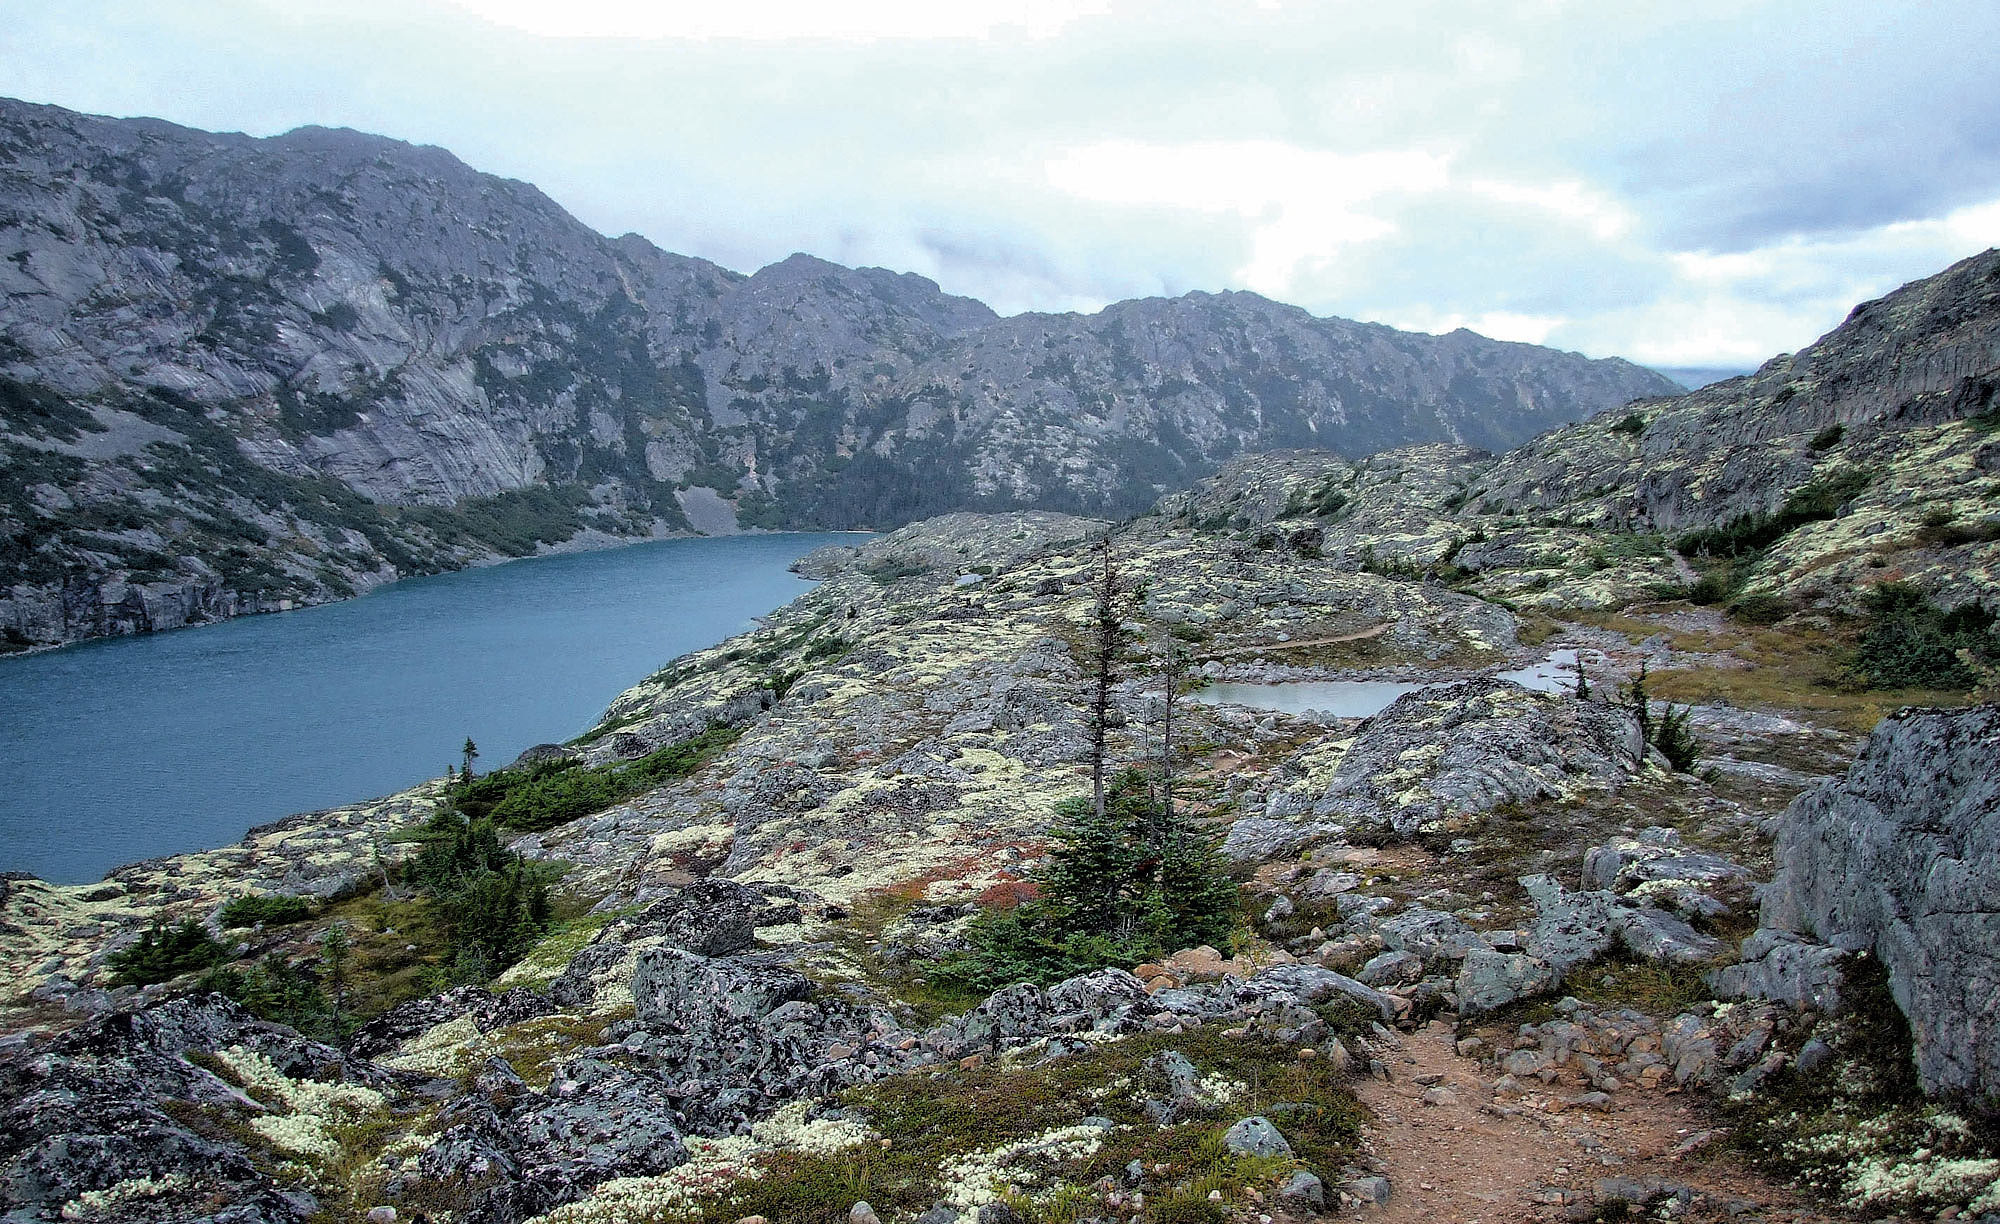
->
[1224,678,1644,858]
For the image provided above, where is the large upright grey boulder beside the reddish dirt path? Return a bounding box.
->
[1744,704,2000,1098]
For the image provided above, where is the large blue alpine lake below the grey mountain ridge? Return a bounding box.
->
[0,534,856,884]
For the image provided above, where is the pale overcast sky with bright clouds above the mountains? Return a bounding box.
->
[0,0,2000,366]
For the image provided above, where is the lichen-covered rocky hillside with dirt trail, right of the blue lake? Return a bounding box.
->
[0,244,2000,1224]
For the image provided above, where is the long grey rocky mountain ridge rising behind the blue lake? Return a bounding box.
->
[0,102,1672,648]
